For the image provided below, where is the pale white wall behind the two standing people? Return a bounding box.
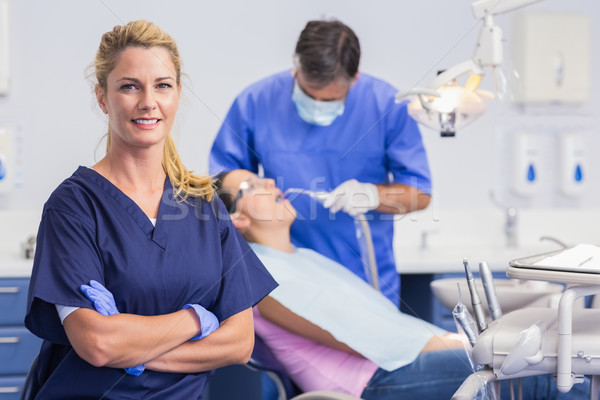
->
[0,0,600,214]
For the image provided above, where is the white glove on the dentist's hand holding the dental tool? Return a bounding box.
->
[323,179,379,217]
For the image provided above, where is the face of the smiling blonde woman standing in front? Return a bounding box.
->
[96,47,181,152]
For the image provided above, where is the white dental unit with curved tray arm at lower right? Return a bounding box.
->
[452,250,600,400]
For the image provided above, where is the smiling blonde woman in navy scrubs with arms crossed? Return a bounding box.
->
[25,21,276,399]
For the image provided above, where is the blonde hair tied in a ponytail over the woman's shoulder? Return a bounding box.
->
[94,20,214,201]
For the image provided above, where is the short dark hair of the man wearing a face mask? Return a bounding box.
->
[294,20,360,86]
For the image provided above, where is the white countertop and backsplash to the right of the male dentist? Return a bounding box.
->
[394,208,600,274]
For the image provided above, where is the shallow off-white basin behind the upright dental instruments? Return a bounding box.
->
[430,278,564,317]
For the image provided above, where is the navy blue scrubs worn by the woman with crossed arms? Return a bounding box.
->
[25,167,277,400]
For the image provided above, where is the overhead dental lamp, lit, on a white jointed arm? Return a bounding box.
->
[396,0,541,137]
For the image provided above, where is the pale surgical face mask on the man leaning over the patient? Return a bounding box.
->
[292,81,345,126]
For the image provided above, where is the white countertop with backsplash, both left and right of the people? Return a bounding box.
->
[0,208,600,278]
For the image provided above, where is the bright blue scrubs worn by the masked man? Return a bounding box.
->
[210,71,431,304]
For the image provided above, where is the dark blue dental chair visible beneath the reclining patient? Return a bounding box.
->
[246,335,360,400]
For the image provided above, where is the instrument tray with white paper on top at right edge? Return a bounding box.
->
[506,244,600,285]
